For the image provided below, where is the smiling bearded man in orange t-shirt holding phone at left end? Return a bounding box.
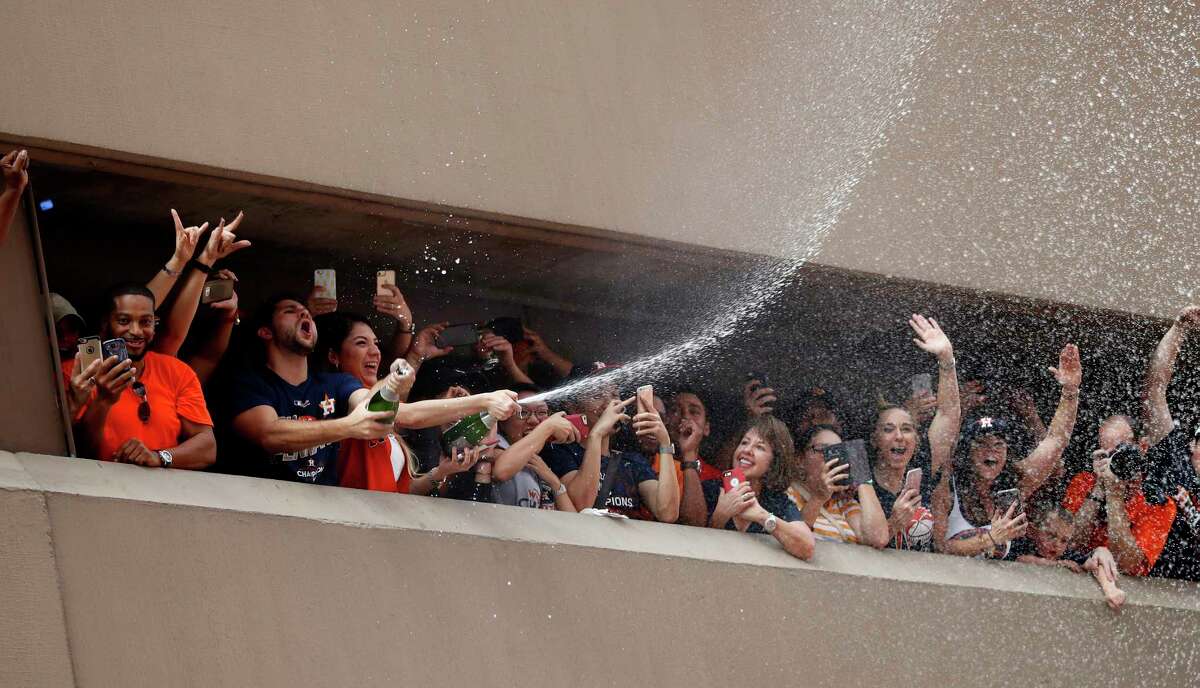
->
[67,283,217,468]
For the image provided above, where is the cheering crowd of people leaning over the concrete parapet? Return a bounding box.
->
[9,152,1200,609]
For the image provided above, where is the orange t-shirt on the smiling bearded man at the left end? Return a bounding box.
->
[62,352,212,461]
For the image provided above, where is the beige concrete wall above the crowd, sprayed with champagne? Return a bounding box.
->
[0,0,1200,315]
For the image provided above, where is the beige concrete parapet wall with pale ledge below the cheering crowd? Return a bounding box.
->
[0,455,1200,687]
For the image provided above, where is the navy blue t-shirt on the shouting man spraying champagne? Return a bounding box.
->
[230,367,362,485]
